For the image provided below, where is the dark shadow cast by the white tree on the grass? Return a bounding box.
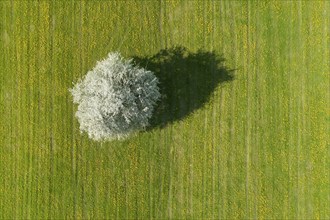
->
[133,46,234,130]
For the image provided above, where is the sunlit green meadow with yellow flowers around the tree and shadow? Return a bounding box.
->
[0,0,330,219]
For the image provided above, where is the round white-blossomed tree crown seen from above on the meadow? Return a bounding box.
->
[70,53,160,141]
